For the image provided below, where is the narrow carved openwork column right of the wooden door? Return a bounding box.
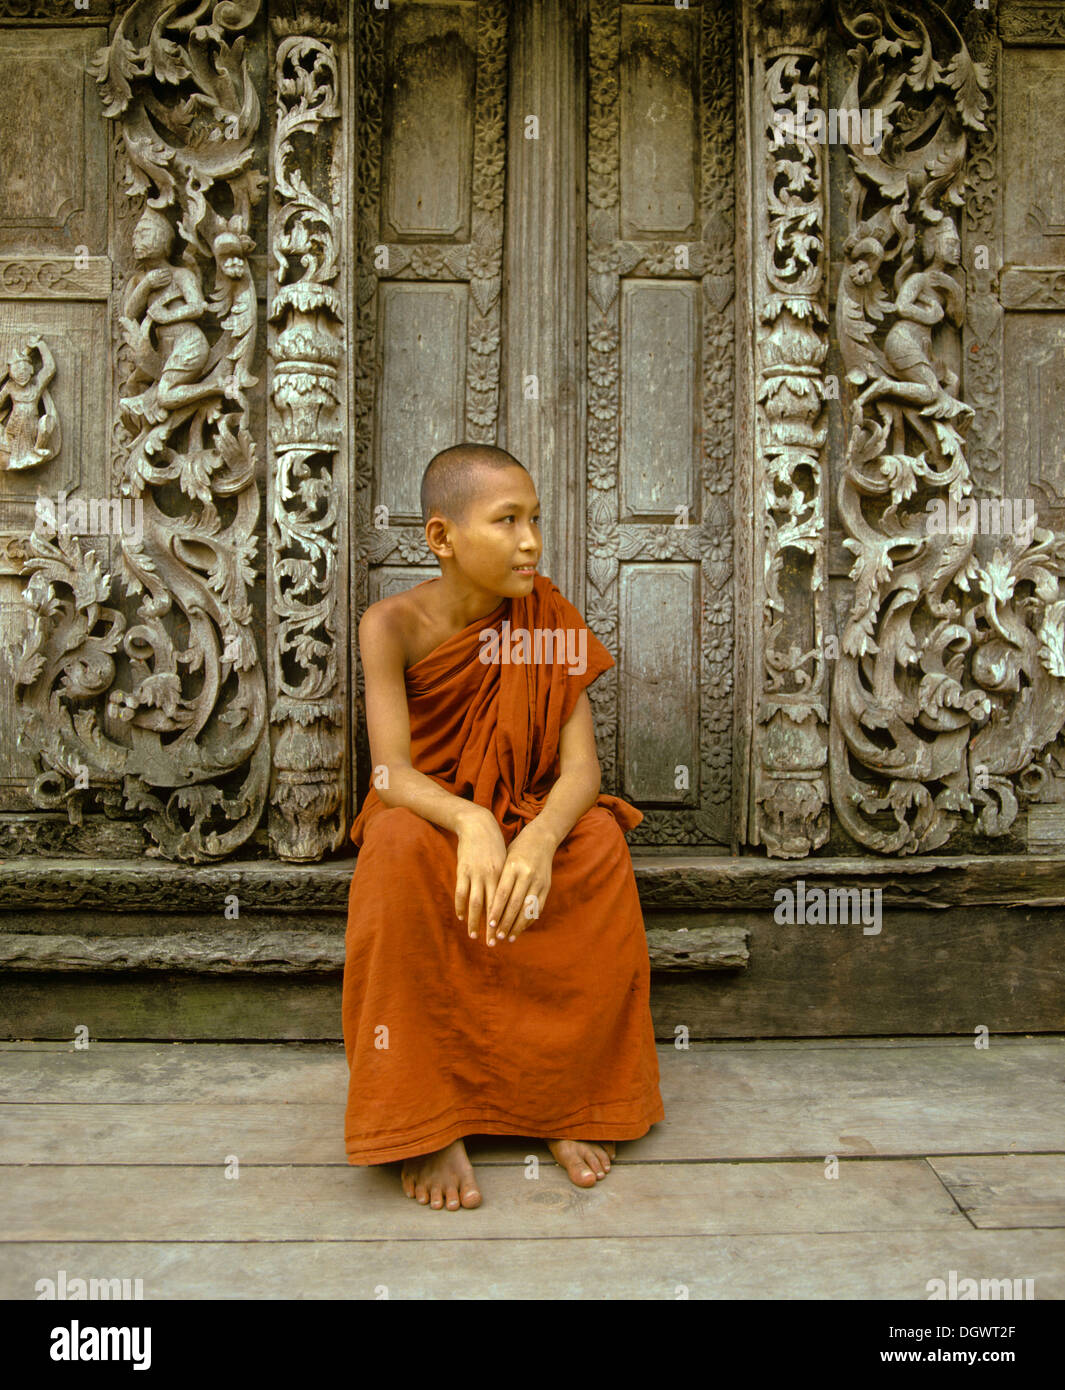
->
[747,0,829,858]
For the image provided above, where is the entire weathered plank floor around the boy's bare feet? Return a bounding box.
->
[0,1038,1065,1301]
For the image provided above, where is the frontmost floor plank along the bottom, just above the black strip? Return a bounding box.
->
[0,1239,1065,1301]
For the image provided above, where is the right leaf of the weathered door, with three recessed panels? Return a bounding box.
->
[584,0,734,845]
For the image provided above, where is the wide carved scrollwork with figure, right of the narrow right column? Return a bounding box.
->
[831,3,1065,853]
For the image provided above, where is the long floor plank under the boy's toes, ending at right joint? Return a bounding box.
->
[0,1159,965,1241]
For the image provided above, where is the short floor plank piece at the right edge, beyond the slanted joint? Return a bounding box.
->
[930,1152,1065,1230]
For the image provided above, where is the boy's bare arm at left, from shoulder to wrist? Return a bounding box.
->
[359,603,482,835]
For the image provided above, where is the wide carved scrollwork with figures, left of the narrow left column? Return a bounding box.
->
[17,0,270,860]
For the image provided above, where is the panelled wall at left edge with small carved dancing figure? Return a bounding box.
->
[0,19,111,822]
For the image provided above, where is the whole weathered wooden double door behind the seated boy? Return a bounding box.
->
[352,0,735,849]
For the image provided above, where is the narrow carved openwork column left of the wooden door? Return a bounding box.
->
[267,13,346,860]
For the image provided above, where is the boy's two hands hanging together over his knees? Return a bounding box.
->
[455,805,558,947]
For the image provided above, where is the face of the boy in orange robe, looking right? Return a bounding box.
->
[449,468,544,594]
